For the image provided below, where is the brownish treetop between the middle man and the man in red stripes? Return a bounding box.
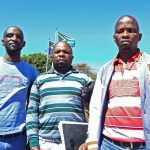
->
[74,63,96,80]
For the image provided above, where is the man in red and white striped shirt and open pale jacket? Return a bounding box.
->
[80,15,150,150]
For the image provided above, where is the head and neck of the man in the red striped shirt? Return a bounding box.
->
[113,15,142,62]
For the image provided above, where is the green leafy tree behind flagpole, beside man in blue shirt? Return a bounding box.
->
[22,53,52,73]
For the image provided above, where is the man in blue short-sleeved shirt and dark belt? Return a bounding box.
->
[0,26,37,150]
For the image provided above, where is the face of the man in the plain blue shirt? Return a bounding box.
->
[2,27,25,52]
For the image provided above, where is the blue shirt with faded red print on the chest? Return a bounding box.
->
[0,58,37,135]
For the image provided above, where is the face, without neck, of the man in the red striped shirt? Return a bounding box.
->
[114,17,142,51]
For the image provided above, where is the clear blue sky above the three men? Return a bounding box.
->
[0,0,150,72]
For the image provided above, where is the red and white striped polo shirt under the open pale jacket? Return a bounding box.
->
[103,51,144,142]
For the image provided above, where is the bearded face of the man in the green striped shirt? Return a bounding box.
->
[52,42,73,70]
